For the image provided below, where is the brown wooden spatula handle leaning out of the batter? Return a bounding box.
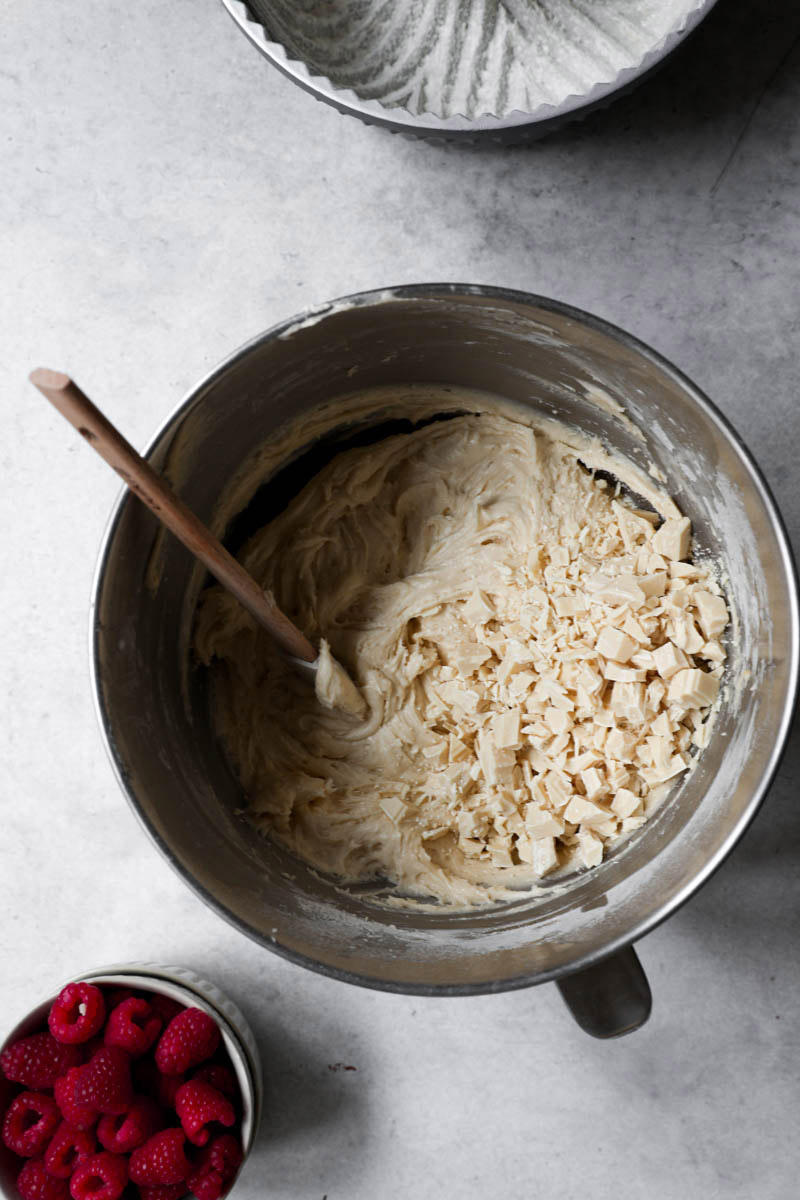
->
[30,367,317,662]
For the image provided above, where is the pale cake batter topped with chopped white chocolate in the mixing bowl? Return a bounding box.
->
[196,413,728,904]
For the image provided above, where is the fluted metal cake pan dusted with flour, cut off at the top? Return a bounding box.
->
[222,0,716,142]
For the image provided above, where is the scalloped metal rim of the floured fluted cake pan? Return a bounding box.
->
[222,0,717,140]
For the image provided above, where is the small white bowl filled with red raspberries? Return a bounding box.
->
[0,964,263,1200]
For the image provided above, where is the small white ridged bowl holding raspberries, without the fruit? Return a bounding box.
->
[0,962,264,1200]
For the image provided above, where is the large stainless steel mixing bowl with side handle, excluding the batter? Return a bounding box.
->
[92,284,798,1034]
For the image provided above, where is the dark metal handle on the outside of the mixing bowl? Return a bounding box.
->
[557,946,652,1038]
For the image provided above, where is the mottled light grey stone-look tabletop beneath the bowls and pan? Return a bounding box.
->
[0,0,800,1200]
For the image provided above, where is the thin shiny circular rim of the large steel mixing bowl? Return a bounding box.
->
[89,283,800,996]
